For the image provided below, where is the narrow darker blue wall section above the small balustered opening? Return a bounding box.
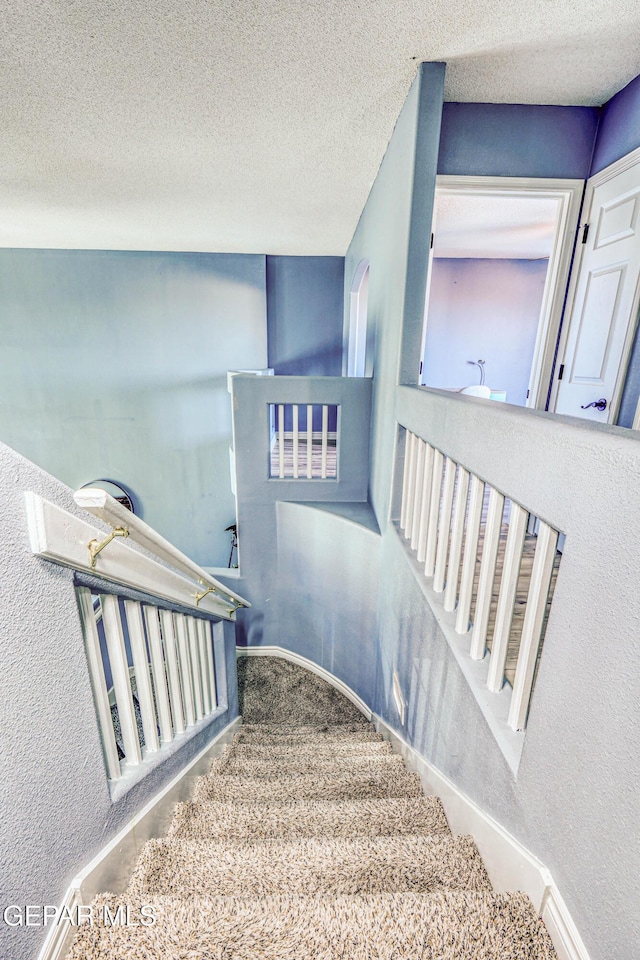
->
[267,256,344,377]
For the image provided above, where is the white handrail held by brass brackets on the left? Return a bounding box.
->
[73,487,251,607]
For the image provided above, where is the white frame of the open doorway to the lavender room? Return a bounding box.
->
[419,176,584,410]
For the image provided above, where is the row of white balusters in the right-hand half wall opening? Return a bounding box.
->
[400,430,559,730]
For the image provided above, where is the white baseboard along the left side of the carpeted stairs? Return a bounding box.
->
[38,717,242,960]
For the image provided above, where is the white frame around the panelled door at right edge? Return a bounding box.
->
[549,147,640,420]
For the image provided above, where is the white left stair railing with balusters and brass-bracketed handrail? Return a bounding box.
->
[25,489,249,781]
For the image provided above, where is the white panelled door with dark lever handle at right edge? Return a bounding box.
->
[555,163,640,423]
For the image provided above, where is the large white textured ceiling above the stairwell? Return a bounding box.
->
[0,0,640,254]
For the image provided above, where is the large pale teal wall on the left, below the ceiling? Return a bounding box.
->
[0,250,267,566]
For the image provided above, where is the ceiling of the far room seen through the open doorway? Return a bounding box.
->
[433,194,559,260]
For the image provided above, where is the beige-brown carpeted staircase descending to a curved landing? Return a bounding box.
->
[72,657,555,960]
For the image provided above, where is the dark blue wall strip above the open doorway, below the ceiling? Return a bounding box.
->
[438,103,600,179]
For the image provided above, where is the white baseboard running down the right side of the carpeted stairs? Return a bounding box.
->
[373,714,589,960]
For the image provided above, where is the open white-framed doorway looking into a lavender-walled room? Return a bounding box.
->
[420,177,584,409]
